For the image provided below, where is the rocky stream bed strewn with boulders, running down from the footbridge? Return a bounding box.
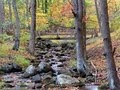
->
[0,38,98,90]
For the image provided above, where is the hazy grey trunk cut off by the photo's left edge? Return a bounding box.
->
[0,0,5,34]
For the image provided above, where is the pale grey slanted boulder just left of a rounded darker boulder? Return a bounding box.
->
[23,65,36,78]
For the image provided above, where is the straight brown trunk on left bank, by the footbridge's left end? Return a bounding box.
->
[29,0,36,55]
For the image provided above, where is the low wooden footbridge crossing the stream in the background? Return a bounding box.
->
[36,27,98,40]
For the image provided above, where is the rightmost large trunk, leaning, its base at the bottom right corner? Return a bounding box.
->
[99,0,120,90]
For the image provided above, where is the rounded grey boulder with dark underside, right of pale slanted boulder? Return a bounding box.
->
[37,62,52,73]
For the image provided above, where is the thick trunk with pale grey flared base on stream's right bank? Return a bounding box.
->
[73,0,91,77]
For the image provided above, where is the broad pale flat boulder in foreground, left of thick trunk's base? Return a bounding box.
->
[56,74,79,85]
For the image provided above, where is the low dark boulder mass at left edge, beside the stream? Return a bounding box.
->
[0,63,22,73]
